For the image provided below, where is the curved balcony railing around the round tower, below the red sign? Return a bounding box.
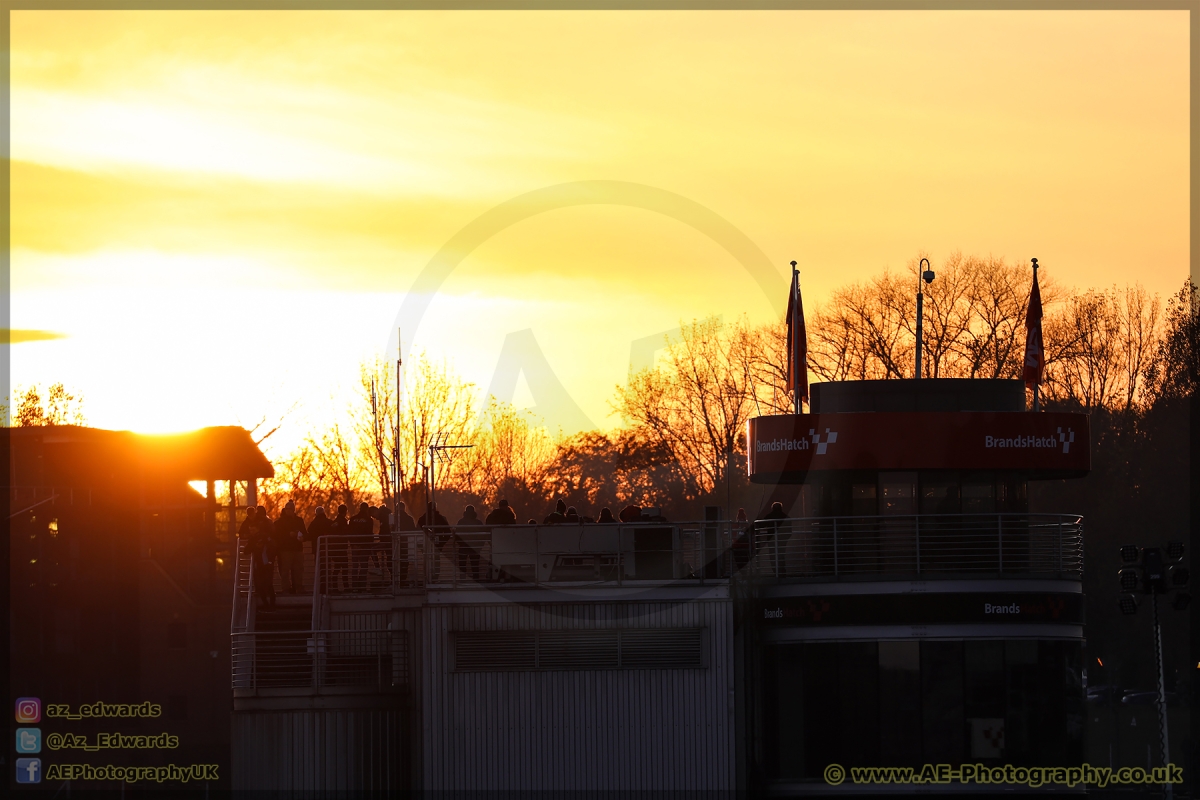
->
[750,513,1084,578]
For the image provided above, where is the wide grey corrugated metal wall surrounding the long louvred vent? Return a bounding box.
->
[422,600,736,790]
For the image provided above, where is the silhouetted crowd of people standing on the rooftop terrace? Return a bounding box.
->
[238,499,786,608]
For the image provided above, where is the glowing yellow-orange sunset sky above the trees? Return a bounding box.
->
[8,11,1189,450]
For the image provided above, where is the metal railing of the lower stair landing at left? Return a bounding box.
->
[230,631,408,692]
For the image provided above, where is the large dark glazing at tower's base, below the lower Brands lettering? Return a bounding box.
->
[761,639,1084,783]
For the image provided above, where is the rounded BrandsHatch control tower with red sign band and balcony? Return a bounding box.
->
[745,379,1090,795]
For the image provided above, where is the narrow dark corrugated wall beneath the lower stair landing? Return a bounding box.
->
[233,709,408,793]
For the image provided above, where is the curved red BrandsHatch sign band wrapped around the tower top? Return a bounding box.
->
[746,411,1091,483]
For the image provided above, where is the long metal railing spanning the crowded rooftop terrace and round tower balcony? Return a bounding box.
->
[297,513,1084,597]
